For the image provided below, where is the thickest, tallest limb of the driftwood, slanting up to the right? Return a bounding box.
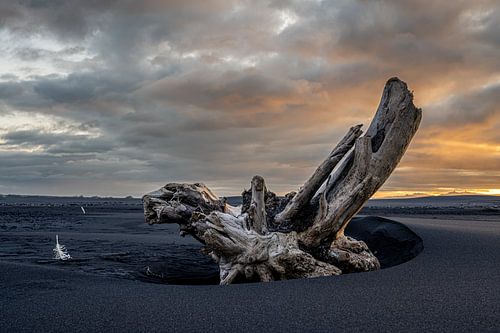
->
[300,78,422,248]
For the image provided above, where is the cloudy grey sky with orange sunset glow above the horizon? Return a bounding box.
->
[0,0,500,197]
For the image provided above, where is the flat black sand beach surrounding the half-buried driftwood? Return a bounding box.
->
[0,199,500,332]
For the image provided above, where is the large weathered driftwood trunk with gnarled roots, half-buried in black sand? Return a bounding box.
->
[143,78,421,284]
